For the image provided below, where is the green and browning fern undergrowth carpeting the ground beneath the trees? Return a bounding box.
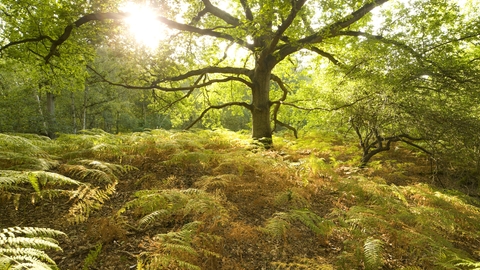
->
[0,130,480,269]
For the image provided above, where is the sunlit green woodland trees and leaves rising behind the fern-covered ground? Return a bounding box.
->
[0,0,480,161]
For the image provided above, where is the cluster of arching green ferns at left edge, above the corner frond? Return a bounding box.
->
[0,134,135,223]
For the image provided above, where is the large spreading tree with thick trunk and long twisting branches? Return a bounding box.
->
[0,0,476,145]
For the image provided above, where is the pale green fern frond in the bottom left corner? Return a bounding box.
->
[0,227,65,269]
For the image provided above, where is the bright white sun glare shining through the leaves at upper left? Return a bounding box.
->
[122,2,167,50]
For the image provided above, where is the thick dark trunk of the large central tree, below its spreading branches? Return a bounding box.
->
[251,61,272,148]
